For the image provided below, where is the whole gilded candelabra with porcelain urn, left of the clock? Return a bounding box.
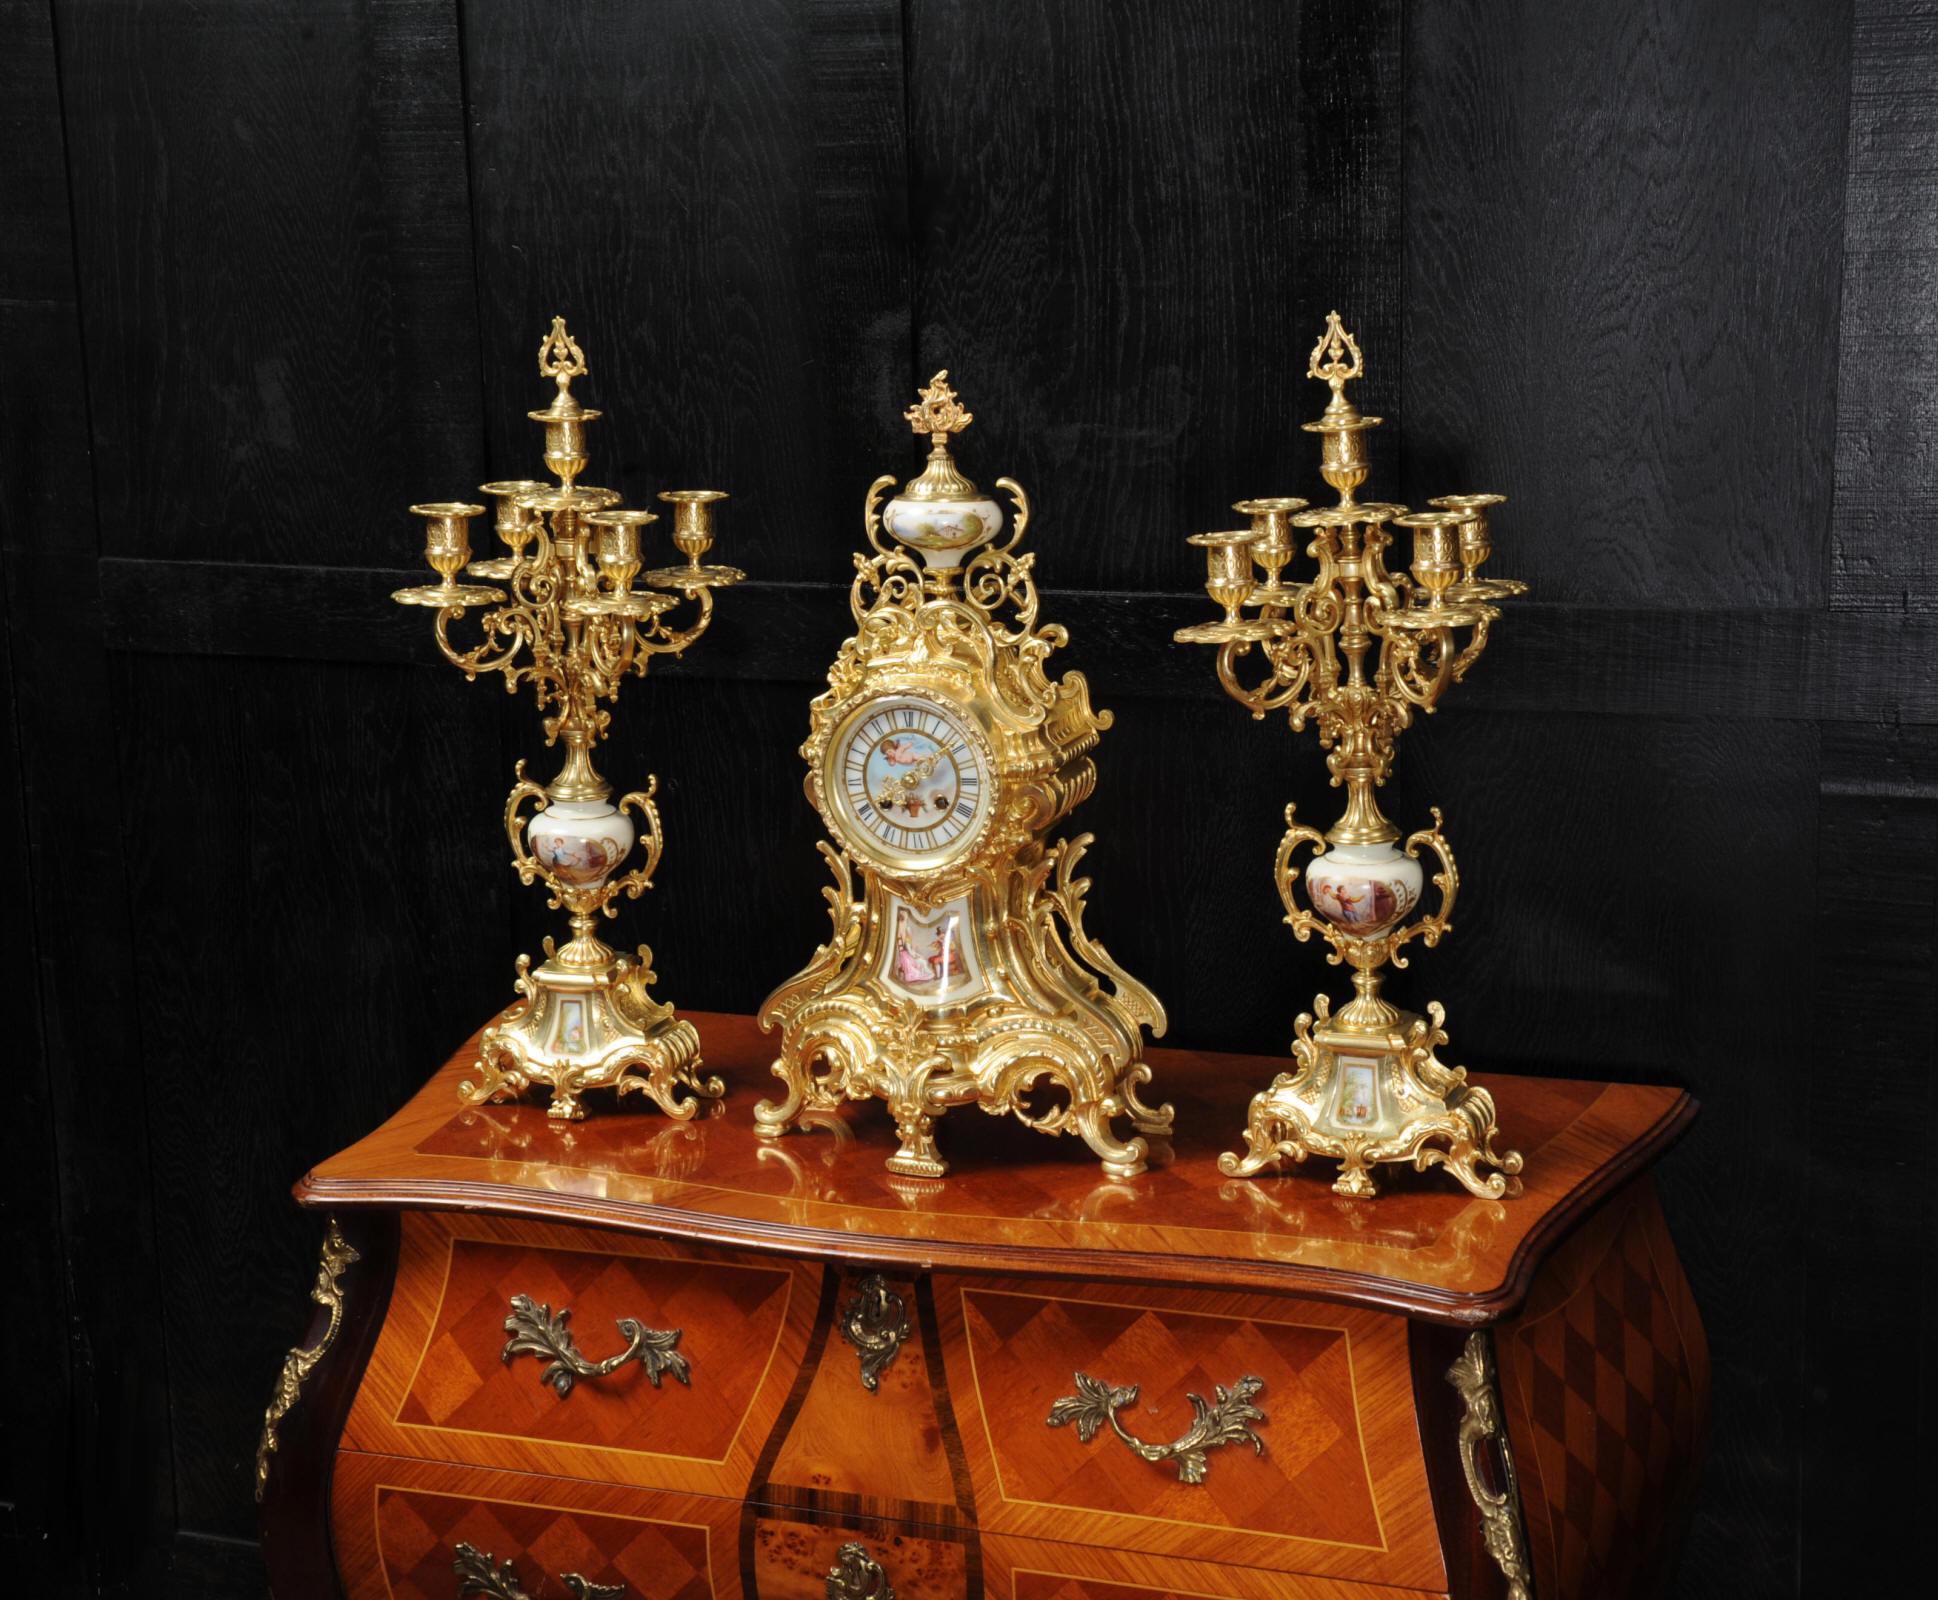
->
[391,318,742,1120]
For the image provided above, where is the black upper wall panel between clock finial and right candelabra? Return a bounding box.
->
[906,0,1317,591]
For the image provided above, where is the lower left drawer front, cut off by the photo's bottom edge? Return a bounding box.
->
[331,1451,742,1600]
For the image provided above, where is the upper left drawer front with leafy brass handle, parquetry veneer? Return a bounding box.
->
[345,1213,822,1497]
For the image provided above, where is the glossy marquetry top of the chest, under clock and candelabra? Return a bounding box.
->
[297,1011,1696,1323]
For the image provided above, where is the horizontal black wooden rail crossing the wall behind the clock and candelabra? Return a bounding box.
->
[101,560,1938,726]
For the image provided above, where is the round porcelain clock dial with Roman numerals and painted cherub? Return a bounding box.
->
[822,693,992,872]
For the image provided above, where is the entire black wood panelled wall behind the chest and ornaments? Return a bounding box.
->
[0,0,1938,1596]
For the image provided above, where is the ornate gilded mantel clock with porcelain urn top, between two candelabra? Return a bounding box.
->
[754,372,1171,1178]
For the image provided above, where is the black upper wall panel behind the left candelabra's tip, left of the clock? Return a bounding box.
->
[459,0,907,579]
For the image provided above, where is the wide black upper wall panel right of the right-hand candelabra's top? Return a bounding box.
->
[1401,0,1849,606]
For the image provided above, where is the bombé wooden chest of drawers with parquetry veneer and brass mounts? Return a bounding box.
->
[262,1017,1707,1600]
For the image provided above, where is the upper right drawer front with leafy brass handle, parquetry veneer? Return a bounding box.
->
[934,1275,1446,1592]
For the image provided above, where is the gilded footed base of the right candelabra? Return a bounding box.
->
[1217,996,1521,1199]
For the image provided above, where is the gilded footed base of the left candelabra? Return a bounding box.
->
[457,939,727,1122]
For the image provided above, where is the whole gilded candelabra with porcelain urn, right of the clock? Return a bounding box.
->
[1176,312,1527,1199]
